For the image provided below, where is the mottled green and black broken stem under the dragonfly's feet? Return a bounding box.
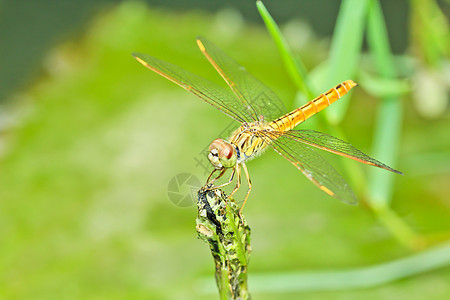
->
[196,188,250,299]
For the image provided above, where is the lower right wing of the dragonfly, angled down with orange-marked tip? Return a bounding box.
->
[259,131,358,204]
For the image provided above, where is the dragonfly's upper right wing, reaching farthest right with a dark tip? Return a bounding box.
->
[285,130,403,175]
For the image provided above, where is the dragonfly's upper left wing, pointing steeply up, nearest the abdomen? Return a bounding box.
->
[197,37,286,122]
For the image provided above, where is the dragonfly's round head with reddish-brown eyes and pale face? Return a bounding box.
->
[208,139,237,169]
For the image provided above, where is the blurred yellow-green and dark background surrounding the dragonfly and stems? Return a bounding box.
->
[0,1,450,299]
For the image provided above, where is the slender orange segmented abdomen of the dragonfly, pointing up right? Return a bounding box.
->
[269,80,357,131]
